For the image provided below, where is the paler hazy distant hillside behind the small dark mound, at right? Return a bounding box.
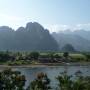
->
[52,31,90,51]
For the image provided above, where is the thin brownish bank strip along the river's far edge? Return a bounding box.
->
[0,62,90,68]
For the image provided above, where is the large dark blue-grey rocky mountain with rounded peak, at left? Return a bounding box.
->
[0,22,58,51]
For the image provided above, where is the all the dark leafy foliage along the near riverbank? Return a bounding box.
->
[0,69,90,90]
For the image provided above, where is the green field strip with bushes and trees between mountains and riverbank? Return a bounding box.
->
[0,51,90,65]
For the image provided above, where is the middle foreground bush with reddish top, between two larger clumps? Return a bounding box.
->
[27,72,51,90]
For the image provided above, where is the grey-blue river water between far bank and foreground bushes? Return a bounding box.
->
[6,66,90,87]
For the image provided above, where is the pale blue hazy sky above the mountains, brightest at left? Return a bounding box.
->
[0,0,90,32]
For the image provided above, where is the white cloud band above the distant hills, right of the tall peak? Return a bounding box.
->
[47,23,90,32]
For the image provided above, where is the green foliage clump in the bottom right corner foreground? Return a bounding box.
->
[57,71,90,90]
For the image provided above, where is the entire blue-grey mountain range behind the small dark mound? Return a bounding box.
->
[0,22,90,51]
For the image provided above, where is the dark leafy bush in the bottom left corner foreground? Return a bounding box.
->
[0,69,26,90]
